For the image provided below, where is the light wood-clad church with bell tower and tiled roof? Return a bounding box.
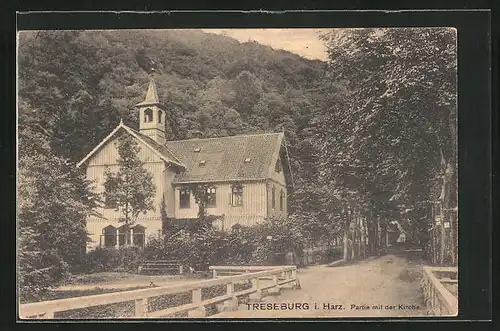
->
[78,80,292,250]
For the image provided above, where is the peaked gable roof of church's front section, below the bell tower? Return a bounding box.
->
[77,121,185,168]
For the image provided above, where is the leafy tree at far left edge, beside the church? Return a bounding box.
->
[17,101,97,301]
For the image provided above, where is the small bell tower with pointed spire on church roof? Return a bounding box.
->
[135,79,167,145]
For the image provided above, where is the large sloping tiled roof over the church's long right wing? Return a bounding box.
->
[166,133,284,183]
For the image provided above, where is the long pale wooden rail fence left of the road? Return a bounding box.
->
[19,266,298,319]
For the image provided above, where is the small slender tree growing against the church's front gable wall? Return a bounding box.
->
[104,134,156,244]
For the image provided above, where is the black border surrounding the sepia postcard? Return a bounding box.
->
[2,10,493,328]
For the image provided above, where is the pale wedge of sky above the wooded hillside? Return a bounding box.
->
[203,29,327,61]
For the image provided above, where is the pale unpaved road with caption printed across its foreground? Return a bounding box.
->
[211,252,426,318]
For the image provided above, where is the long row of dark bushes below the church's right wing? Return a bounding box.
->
[135,218,310,271]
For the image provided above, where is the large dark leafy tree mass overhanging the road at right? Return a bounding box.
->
[319,28,456,264]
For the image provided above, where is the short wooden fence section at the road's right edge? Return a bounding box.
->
[422,266,458,316]
